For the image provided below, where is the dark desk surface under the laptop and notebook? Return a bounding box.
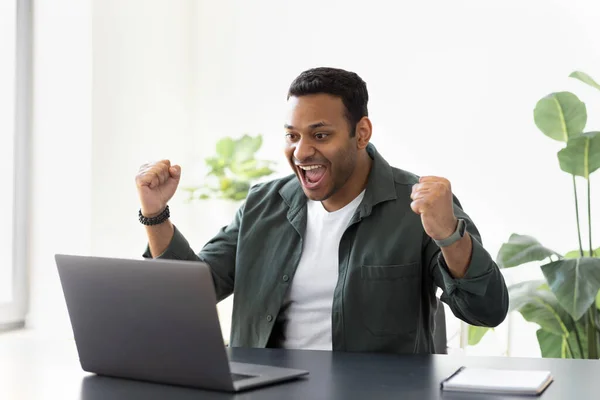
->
[0,334,600,400]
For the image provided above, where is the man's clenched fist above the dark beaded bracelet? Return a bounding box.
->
[135,160,181,217]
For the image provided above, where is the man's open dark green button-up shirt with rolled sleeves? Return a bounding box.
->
[144,145,508,353]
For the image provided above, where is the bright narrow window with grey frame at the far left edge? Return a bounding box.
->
[0,0,31,330]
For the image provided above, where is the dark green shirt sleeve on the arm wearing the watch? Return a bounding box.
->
[425,198,508,327]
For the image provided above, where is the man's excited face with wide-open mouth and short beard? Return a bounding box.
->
[285,94,358,201]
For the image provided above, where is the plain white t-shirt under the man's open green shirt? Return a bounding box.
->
[281,190,365,350]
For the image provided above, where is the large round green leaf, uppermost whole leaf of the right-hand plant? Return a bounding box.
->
[533,92,587,142]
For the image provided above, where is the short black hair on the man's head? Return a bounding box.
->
[287,67,369,136]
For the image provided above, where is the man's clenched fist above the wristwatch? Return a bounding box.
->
[410,176,458,240]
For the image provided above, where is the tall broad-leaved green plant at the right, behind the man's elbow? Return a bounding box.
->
[469,71,600,359]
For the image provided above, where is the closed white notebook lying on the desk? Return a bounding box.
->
[441,367,553,395]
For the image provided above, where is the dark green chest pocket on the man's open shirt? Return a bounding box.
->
[360,262,421,336]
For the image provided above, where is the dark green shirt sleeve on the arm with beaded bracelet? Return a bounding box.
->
[143,202,243,301]
